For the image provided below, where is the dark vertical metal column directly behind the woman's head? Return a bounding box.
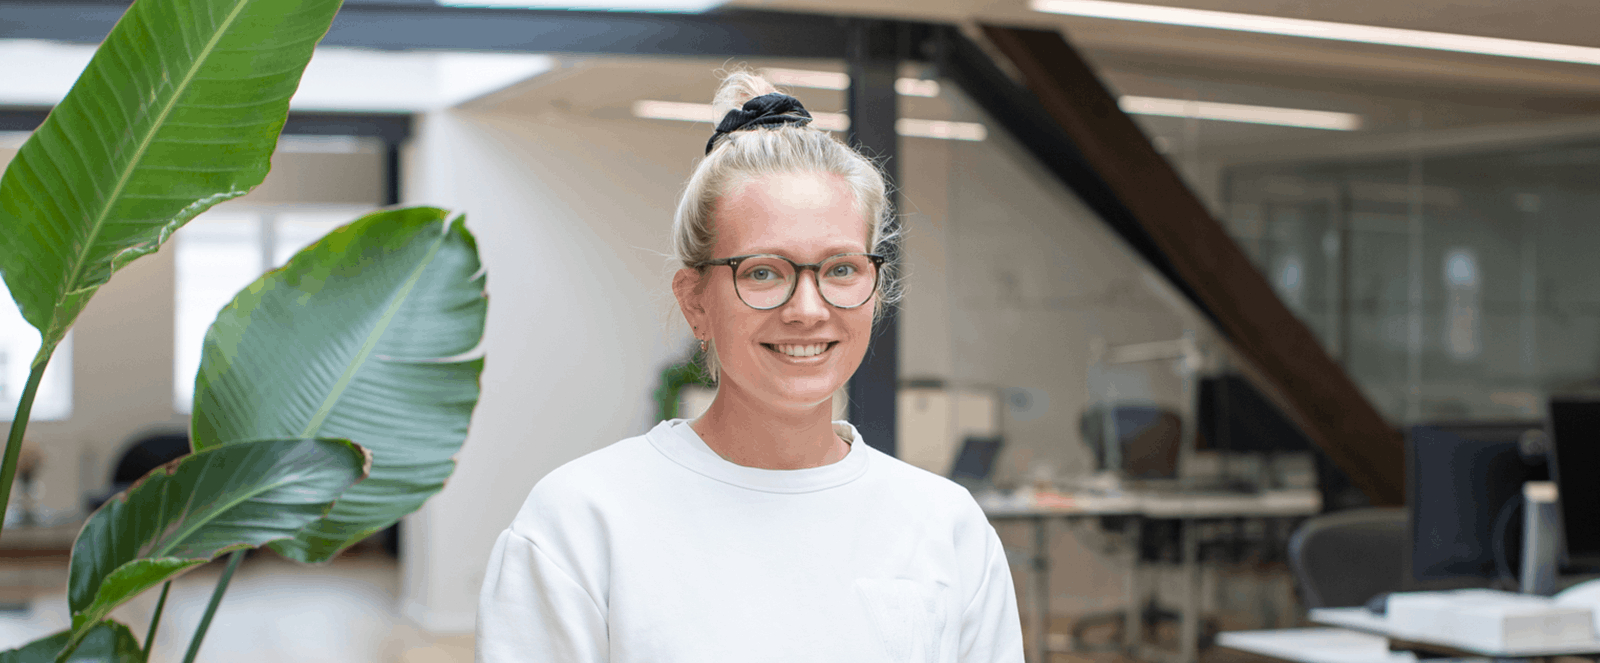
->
[846,21,906,456]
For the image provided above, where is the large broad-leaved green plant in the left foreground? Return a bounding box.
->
[0,0,486,663]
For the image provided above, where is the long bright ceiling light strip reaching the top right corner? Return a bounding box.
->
[1029,0,1600,64]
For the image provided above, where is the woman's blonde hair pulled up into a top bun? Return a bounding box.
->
[672,69,901,380]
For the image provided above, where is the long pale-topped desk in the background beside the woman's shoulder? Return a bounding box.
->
[979,488,1322,663]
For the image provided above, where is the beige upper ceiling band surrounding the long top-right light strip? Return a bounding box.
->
[730,0,1600,99]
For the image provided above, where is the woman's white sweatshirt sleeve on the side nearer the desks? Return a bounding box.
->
[958,527,1022,663]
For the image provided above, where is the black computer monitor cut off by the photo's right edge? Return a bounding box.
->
[1550,397,1600,569]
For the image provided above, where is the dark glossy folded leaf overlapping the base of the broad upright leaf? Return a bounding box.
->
[67,439,370,643]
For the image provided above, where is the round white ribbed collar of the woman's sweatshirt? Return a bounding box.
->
[645,420,870,493]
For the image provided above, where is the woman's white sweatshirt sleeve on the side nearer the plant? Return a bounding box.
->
[477,530,610,663]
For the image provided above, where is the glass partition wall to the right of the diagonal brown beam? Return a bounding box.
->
[1224,139,1600,423]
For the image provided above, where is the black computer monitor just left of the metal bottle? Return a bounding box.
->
[1406,423,1549,583]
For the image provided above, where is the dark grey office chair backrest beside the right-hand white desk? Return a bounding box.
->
[1290,508,1410,609]
